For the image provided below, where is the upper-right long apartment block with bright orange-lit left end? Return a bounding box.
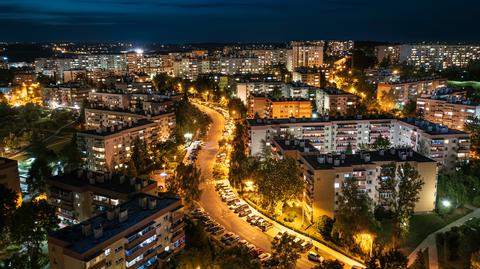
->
[377,78,447,108]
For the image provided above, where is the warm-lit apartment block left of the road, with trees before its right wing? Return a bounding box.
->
[77,119,174,172]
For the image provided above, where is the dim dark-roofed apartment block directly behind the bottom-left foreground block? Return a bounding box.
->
[46,169,157,224]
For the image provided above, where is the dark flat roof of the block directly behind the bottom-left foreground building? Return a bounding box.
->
[47,170,156,195]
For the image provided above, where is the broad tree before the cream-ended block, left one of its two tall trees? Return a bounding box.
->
[334,178,378,244]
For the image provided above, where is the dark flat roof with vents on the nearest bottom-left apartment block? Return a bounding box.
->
[49,193,182,254]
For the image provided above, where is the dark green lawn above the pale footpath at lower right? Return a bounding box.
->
[379,208,471,253]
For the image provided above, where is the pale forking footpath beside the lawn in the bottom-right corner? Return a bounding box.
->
[408,208,480,269]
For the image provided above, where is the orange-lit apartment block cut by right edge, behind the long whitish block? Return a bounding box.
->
[417,96,480,130]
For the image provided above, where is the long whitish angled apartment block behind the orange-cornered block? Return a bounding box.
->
[248,116,470,169]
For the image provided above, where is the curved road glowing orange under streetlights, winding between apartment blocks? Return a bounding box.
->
[193,105,361,269]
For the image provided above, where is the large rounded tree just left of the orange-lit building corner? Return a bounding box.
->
[257,156,305,212]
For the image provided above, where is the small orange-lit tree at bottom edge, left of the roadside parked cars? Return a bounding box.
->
[272,233,300,269]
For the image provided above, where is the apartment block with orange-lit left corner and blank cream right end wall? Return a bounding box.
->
[273,140,437,221]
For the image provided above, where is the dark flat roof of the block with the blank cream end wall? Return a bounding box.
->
[302,149,435,170]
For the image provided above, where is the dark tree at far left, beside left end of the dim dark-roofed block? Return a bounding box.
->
[27,155,52,195]
